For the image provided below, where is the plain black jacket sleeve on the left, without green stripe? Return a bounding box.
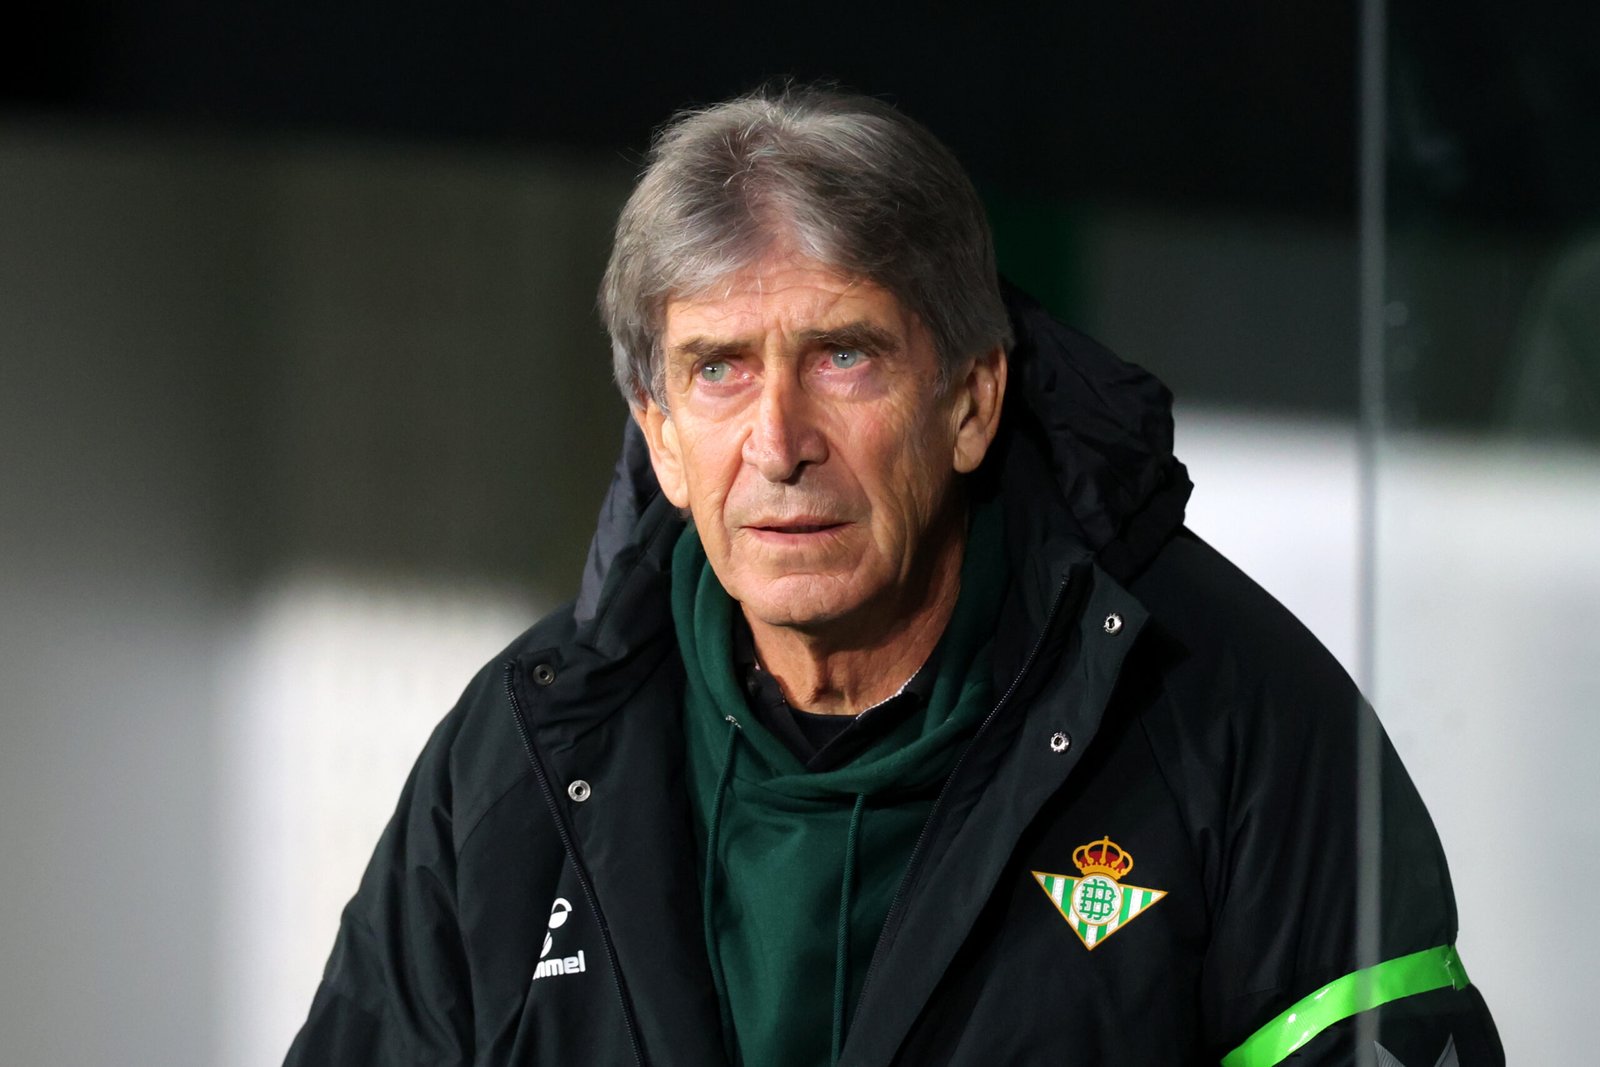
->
[286,709,472,1067]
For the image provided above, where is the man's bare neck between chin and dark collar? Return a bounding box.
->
[744,523,966,715]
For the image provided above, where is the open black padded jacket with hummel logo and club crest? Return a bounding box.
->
[288,298,1504,1067]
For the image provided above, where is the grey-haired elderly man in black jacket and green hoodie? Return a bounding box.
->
[290,90,1502,1067]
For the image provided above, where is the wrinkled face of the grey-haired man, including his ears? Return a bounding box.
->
[635,253,1005,632]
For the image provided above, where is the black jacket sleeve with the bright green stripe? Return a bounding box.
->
[1203,639,1506,1067]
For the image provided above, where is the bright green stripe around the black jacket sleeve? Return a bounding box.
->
[1222,945,1467,1067]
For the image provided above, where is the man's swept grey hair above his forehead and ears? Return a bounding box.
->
[600,86,1011,408]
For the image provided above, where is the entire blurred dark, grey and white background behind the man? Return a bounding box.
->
[0,0,1600,1067]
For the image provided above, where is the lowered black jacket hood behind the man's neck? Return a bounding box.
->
[576,285,1192,625]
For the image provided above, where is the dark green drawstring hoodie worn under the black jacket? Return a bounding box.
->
[672,506,1005,1067]
